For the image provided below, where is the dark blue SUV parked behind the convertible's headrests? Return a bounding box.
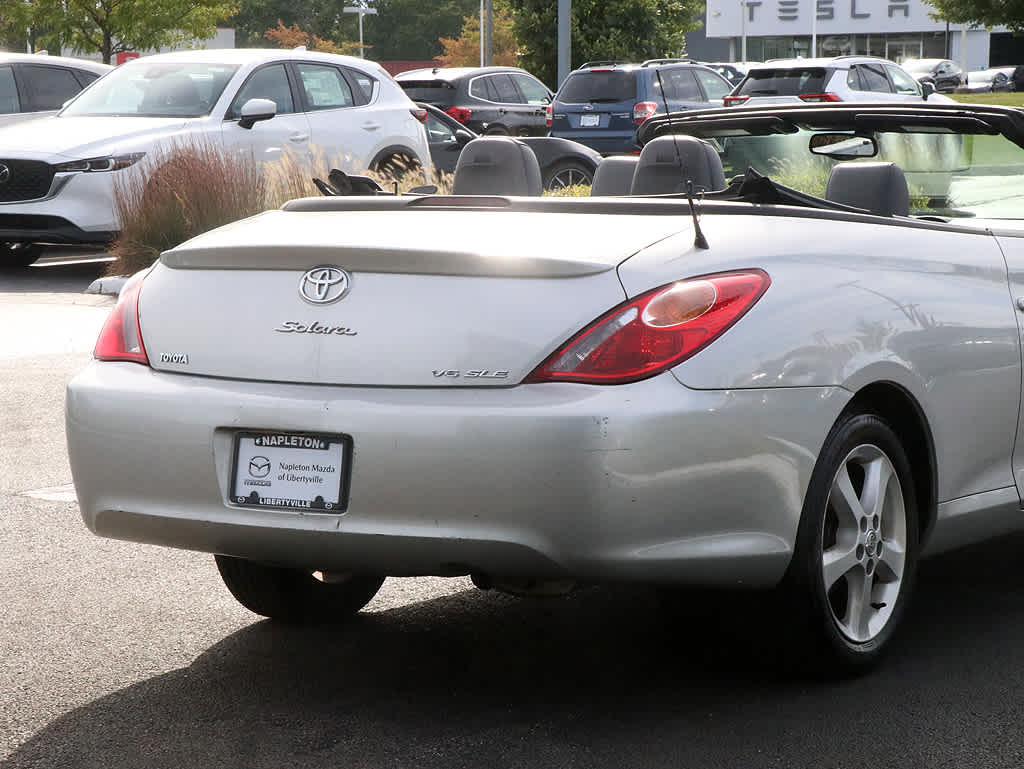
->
[548,58,732,155]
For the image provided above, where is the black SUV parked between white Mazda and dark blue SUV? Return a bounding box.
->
[395,67,551,136]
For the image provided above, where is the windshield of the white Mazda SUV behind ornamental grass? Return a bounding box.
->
[60,60,239,118]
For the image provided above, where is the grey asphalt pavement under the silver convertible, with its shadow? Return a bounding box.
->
[0,263,1024,769]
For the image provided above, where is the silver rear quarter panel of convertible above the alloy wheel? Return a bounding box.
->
[620,211,1021,501]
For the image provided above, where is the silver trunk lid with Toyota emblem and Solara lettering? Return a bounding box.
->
[139,205,688,387]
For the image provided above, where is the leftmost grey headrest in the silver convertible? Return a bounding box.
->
[452,136,544,197]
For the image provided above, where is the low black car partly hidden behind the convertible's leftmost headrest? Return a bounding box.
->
[418,102,601,189]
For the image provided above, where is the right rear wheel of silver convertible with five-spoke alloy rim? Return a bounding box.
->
[783,413,919,675]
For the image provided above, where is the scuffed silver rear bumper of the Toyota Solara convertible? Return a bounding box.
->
[67,362,848,586]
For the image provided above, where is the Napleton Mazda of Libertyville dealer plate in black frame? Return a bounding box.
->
[231,432,352,513]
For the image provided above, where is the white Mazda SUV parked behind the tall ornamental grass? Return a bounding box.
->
[0,49,431,266]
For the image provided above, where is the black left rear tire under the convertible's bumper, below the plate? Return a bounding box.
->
[215,555,384,624]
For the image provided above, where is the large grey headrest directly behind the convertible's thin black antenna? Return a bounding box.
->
[630,136,725,195]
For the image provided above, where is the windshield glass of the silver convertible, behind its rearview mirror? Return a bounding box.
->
[701,125,1024,219]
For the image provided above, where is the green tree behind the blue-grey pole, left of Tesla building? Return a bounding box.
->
[511,0,703,86]
